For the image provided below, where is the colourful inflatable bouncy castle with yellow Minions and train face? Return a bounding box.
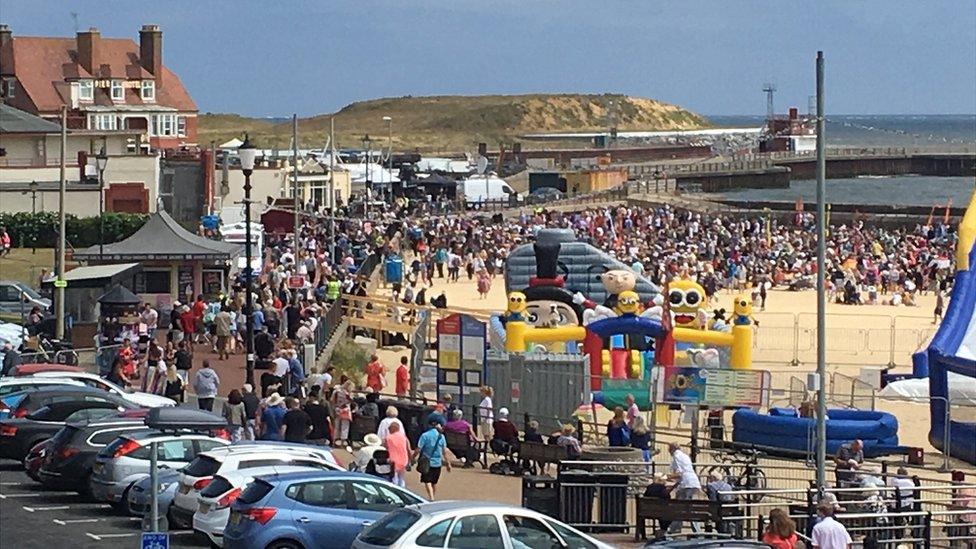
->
[491,231,753,391]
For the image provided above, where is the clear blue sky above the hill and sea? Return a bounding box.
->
[0,0,976,116]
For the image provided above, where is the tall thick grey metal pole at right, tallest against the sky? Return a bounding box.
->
[817,51,827,489]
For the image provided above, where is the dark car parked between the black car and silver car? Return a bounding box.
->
[37,414,152,495]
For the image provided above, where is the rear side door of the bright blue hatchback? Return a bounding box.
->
[285,479,363,547]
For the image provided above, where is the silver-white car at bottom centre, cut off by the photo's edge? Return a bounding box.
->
[350,498,613,549]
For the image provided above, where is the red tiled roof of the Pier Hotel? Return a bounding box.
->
[12,36,197,112]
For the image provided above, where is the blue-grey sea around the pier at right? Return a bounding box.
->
[707,114,976,206]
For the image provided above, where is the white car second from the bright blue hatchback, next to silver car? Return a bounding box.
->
[170,441,345,528]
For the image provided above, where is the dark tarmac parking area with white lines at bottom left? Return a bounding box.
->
[0,460,209,549]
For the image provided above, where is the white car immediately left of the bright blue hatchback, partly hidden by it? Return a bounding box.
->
[193,465,321,547]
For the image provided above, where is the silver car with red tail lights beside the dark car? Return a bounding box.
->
[91,430,230,510]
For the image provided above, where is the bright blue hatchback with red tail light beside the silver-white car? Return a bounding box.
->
[224,471,425,549]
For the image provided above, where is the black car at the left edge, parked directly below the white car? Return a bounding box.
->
[0,387,132,461]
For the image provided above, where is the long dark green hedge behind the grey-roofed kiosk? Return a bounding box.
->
[0,212,148,249]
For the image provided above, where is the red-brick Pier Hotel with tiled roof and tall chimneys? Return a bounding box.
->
[0,25,197,149]
